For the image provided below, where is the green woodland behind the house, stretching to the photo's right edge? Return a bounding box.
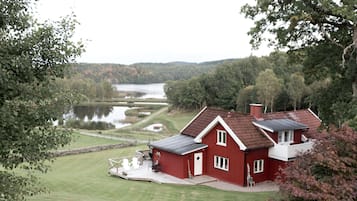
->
[165,52,356,129]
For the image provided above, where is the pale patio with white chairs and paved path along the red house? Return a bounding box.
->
[109,160,279,192]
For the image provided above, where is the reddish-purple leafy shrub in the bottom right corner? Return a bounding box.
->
[279,127,357,201]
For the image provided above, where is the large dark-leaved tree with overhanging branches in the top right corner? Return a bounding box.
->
[242,0,357,123]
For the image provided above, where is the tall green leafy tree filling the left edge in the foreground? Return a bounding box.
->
[0,0,82,200]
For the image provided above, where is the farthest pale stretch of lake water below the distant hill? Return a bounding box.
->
[113,83,166,98]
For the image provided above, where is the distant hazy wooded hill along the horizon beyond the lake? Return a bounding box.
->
[71,59,238,84]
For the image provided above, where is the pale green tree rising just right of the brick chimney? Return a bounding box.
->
[255,69,282,112]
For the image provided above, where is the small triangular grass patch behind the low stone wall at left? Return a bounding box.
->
[61,132,121,150]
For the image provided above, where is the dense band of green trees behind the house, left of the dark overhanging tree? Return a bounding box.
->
[165,52,304,112]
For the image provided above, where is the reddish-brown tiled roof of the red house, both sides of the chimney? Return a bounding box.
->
[181,108,321,149]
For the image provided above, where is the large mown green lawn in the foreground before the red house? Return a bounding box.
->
[29,146,275,201]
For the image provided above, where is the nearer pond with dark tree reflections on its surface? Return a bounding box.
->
[66,105,129,128]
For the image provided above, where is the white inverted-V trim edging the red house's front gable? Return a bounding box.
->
[194,115,247,151]
